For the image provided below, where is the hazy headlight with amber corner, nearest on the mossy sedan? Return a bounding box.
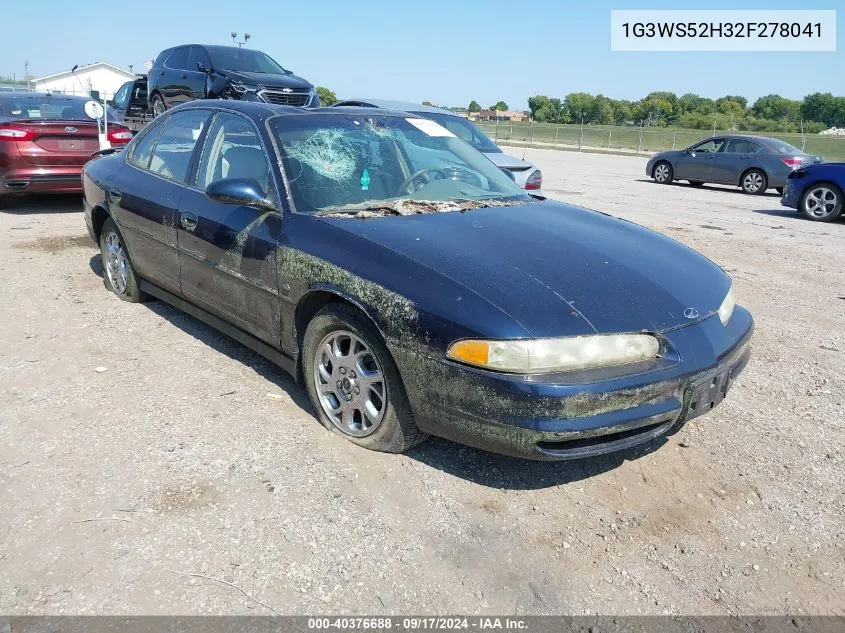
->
[446,334,660,374]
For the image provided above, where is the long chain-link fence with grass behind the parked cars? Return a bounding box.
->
[477,121,845,161]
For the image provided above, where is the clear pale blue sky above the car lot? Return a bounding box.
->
[0,0,845,110]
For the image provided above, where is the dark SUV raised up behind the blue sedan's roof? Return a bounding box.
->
[147,44,320,115]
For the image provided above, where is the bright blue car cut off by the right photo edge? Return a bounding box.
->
[780,163,845,222]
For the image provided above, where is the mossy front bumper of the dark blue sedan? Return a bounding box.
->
[393,306,754,460]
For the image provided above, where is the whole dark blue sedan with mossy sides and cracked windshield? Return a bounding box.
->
[84,101,753,459]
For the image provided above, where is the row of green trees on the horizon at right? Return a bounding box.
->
[528,92,845,133]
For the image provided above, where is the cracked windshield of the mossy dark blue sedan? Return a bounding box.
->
[271,114,533,217]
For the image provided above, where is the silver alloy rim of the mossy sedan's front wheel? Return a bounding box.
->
[313,330,387,437]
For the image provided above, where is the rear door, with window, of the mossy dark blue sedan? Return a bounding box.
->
[106,110,210,294]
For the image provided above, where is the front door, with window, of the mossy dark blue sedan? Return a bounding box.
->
[178,112,282,346]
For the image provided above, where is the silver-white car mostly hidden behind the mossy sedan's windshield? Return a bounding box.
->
[332,99,543,196]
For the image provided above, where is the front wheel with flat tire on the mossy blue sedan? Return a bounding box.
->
[302,303,426,453]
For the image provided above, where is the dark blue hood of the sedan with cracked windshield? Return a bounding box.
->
[323,201,730,337]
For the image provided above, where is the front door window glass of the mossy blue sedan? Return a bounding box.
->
[197,112,270,193]
